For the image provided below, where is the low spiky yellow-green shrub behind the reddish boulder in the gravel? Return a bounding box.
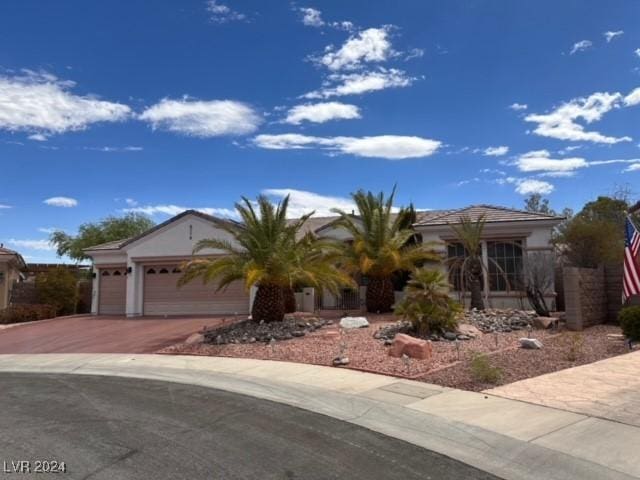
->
[395,268,462,334]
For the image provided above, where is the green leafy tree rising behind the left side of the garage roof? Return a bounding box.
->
[50,213,155,262]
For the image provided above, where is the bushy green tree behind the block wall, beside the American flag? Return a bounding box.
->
[555,196,630,268]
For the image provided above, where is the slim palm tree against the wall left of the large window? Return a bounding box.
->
[447,215,485,310]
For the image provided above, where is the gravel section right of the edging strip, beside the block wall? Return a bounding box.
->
[419,325,628,391]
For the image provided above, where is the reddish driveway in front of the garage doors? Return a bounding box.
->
[0,315,231,353]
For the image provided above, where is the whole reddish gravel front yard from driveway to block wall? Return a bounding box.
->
[161,315,624,380]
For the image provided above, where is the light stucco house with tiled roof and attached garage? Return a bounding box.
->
[86,205,562,316]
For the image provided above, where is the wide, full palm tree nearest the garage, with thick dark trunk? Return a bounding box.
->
[179,196,350,322]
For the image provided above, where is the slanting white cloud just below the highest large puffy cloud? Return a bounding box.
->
[302,68,417,99]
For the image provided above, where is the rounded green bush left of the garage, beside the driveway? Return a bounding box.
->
[36,267,78,315]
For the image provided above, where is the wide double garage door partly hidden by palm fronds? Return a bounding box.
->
[144,265,249,315]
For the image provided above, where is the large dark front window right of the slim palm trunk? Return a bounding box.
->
[487,240,523,292]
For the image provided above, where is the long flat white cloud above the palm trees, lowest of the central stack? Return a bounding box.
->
[253,133,442,160]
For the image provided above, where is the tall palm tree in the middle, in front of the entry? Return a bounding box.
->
[333,187,440,312]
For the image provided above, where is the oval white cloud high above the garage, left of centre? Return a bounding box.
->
[139,97,262,138]
